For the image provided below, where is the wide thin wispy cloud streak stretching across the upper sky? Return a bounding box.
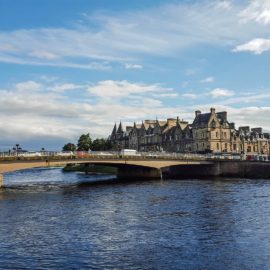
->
[0,0,270,68]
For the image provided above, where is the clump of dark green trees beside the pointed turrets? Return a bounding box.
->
[63,133,112,152]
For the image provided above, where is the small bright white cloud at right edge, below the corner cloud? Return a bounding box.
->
[233,38,270,54]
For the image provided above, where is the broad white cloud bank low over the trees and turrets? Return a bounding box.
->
[0,81,180,147]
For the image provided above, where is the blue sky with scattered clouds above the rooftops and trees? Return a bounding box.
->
[0,0,270,151]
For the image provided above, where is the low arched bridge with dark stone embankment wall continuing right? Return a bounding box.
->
[0,158,270,186]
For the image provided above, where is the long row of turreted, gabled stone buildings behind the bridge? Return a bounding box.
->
[109,108,270,155]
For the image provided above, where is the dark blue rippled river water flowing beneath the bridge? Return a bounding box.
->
[0,168,270,270]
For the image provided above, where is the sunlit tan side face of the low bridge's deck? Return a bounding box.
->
[0,159,213,174]
